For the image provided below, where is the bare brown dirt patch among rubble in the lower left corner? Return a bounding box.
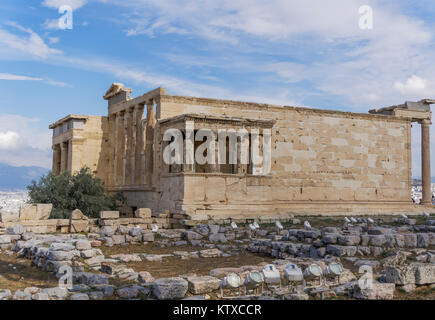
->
[0,254,58,292]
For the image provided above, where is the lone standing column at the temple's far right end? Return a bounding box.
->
[421,120,432,204]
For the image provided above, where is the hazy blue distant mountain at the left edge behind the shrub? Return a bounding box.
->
[0,163,49,191]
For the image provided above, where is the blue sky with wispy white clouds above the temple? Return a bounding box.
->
[0,0,435,175]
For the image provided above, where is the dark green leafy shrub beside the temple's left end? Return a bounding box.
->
[27,167,123,219]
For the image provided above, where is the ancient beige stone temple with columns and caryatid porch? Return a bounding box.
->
[50,83,434,219]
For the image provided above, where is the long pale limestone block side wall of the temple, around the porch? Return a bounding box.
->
[160,96,411,214]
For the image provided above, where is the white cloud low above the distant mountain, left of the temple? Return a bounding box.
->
[0,114,51,168]
